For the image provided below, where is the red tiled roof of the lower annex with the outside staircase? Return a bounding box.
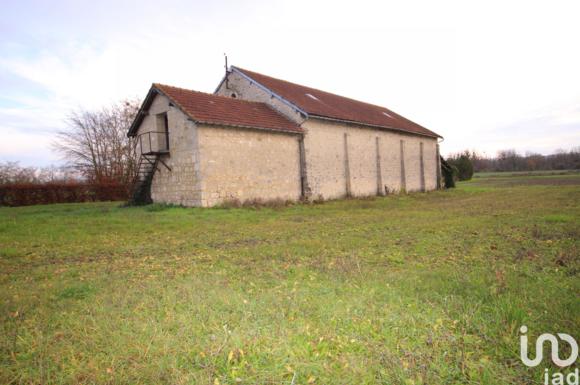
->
[129,83,302,135]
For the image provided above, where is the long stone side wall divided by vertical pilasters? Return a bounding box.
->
[302,119,437,199]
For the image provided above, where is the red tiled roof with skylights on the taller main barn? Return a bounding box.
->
[232,67,441,137]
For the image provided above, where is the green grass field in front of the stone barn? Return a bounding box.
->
[0,174,580,385]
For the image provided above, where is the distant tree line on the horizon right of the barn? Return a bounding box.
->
[447,146,580,180]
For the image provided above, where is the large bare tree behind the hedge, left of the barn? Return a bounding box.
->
[54,100,140,185]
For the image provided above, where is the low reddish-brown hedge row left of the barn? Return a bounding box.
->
[0,183,128,206]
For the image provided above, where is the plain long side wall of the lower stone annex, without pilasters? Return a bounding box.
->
[198,125,301,206]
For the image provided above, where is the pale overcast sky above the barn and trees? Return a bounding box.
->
[0,0,580,166]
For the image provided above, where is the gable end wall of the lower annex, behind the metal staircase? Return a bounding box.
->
[137,95,202,206]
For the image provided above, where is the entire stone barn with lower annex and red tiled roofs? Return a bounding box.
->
[128,66,441,207]
